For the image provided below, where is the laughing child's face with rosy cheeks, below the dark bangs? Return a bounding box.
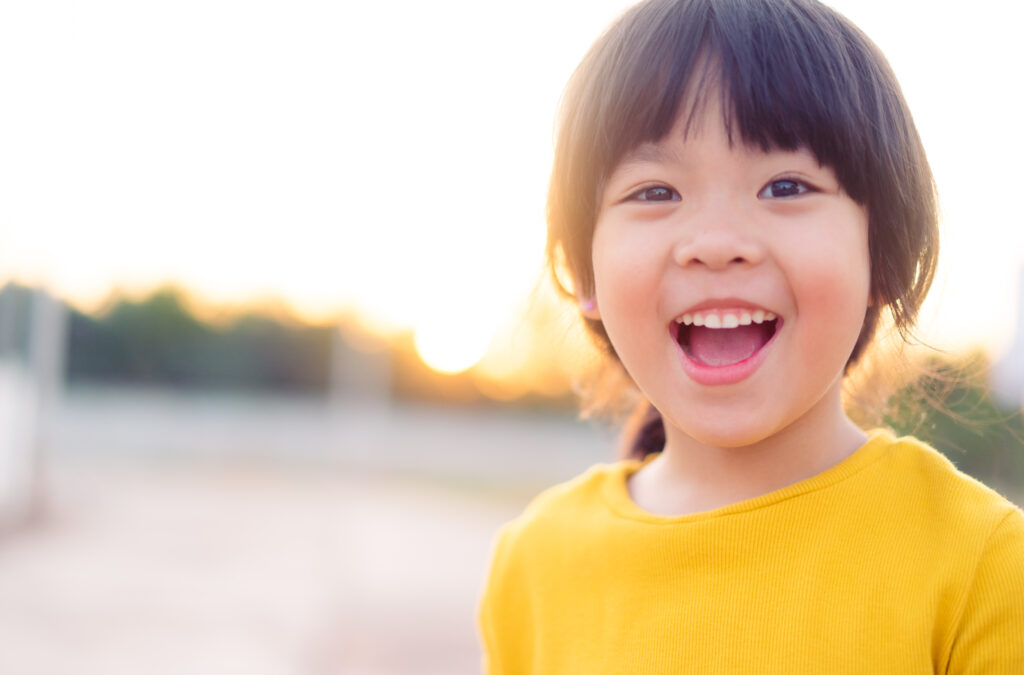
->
[585,102,870,447]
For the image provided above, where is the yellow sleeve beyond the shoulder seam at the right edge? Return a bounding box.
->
[947,509,1024,675]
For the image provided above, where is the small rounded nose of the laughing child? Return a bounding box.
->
[673,209,765,269]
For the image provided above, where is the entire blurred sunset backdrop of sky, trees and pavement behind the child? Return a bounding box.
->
[0,0,1024,675]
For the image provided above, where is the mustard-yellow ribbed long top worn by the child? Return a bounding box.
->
[479,432,1024,675]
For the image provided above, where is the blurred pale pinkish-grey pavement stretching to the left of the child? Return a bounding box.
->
[0,390,612,675]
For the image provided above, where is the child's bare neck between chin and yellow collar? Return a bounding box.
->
[631,383,866,514]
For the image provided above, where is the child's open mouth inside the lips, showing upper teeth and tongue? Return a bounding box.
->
[672,310,781,368]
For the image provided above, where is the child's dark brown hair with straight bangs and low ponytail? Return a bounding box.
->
[547,0,938,457]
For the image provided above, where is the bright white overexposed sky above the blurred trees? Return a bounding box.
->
[0,0,1024,368]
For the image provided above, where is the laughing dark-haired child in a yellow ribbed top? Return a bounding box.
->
[480,0,1024,675]
